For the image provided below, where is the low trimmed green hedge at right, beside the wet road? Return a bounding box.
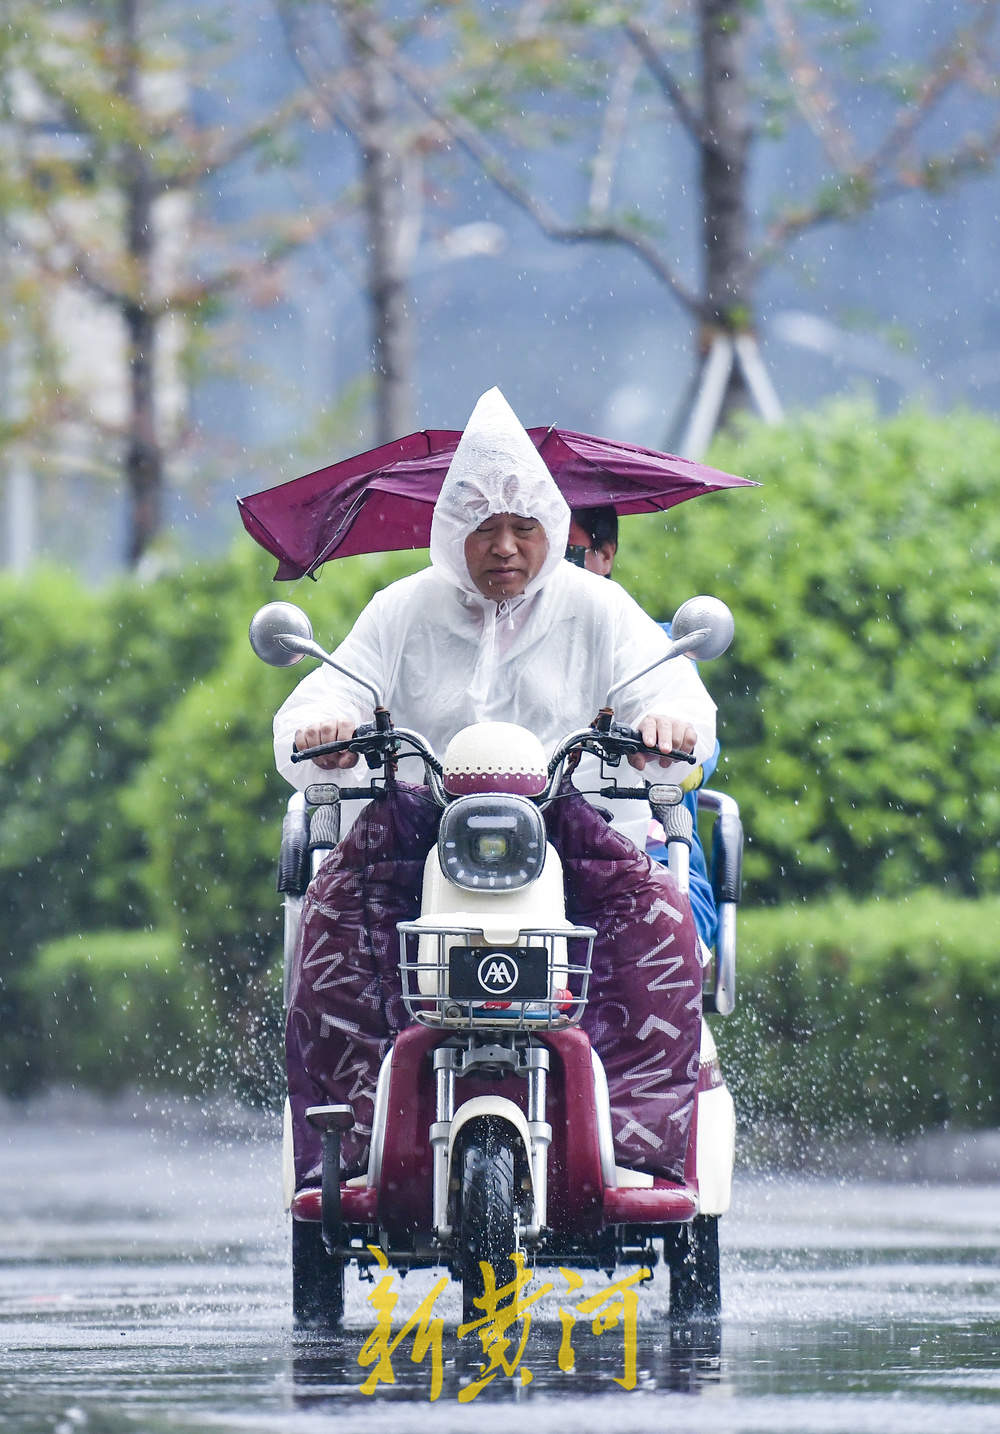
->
[713,891,1000,1143]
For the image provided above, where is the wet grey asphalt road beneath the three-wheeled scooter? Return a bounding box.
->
[0,1103,1000,1434]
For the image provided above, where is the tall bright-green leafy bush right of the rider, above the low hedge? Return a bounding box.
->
[615,404,1000,902]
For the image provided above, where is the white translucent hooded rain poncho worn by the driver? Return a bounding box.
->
[274,389,714,847]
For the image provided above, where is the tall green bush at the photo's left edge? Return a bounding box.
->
[0,545,276,1094]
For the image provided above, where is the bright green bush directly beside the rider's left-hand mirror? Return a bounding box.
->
[122,555,423,1020]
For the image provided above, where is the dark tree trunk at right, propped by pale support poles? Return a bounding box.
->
[699,0,753,422]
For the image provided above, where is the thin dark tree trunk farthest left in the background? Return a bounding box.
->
[119,0,164,568]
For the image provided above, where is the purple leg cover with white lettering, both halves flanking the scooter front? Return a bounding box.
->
[286,783,702,1189]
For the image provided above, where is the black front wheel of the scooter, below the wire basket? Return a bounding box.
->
[456,1119,518,1324]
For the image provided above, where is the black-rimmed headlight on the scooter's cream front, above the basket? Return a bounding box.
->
[438,796,545,891]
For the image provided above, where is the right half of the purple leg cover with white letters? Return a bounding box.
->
[545,786,702,1180]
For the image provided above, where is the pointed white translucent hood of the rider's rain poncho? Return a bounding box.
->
[430,389,570,608]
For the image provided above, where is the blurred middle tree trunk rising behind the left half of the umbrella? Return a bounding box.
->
[346,3,418,443]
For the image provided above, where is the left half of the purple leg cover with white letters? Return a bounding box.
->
[286,782,440,1189]
